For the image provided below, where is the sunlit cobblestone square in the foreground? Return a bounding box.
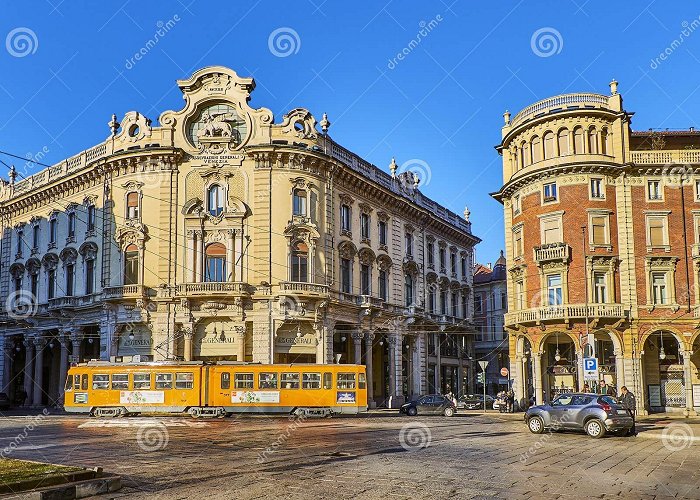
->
[0,413,700,499]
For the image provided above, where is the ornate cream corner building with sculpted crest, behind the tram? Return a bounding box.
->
[0,67,479,405]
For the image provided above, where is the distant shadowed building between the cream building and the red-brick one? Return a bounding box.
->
[474,252,510,395]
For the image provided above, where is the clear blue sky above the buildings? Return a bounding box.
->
[0,0,700,263]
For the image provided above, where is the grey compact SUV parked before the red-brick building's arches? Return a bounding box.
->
[525,393,632,438]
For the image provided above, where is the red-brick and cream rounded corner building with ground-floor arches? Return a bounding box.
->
[493,81,700,415]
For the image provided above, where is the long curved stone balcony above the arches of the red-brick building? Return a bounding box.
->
[505,304,627,325]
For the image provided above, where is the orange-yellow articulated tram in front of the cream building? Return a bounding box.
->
[65,361,367,417]
